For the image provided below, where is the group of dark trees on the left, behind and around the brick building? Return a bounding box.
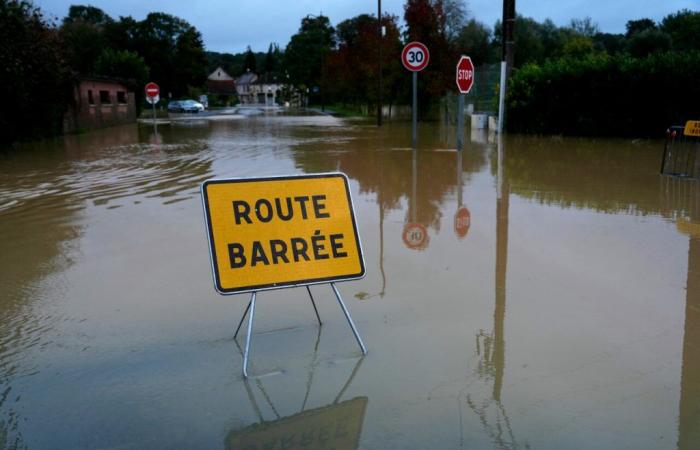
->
[0,0,207,142]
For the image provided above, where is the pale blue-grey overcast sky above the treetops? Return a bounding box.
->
[39,0,700,53]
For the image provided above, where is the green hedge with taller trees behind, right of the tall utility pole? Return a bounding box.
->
[506,10,700,137]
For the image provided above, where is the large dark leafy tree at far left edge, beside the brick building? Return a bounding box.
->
[0,0,73,142]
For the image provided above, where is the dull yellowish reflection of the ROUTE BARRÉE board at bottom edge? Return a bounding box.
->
[226,397,367,450]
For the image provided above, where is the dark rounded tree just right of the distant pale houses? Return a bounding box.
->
[284,15,335,88]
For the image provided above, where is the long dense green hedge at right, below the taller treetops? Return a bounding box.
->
[506,51,700,137]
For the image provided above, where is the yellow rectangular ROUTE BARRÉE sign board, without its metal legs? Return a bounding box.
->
[202,173,365,294]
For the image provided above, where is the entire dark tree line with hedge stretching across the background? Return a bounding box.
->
[0,0,700,142]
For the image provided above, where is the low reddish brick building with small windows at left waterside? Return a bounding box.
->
[63,78,136,133]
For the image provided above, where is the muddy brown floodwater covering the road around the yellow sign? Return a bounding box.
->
[0,114,700,450]
